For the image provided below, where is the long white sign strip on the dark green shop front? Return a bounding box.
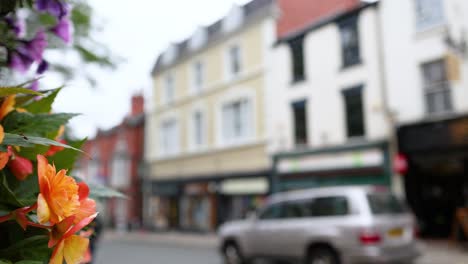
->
[278,148,384,173]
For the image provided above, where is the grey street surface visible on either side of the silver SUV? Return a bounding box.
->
[95,232,468,264]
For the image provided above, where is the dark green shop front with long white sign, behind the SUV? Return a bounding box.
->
[272,141,391,192]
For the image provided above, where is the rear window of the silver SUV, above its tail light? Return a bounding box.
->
[367,193,408,214]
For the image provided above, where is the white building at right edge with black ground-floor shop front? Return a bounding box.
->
[380,0,468,237]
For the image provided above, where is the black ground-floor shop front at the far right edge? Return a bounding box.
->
[398,116,468,238]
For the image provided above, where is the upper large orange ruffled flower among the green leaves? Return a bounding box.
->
[37,155,80,225]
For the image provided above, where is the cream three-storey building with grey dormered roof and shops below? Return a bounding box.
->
[145,0,275,230]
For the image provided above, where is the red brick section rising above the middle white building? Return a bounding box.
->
[276,0,360,38]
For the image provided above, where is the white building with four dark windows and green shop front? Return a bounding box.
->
[267,1,391,191]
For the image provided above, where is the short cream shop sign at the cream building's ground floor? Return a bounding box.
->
[220,177,270,195]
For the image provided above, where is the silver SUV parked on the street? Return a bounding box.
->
[219,186,419,264]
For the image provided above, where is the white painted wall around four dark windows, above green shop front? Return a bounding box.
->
[266,8,388,153]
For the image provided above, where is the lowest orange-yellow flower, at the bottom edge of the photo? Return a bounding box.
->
[48,214,97,264]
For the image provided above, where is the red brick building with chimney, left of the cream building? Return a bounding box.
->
[80,95,145,231]
